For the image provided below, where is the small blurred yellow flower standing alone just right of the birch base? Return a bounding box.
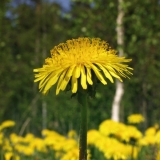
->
[128,114,144,124]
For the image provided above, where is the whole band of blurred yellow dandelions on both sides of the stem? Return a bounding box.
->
[0,120,160,160]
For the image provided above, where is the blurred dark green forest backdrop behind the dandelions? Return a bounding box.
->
[0,0,160,136]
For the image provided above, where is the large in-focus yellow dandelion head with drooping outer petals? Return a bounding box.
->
[33,38,132,94]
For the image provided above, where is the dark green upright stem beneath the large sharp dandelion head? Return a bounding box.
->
[78,93,88,160]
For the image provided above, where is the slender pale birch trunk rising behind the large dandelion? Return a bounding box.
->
[111,0,124,121]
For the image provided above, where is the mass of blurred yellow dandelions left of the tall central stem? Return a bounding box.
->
[0,121,90,160]
